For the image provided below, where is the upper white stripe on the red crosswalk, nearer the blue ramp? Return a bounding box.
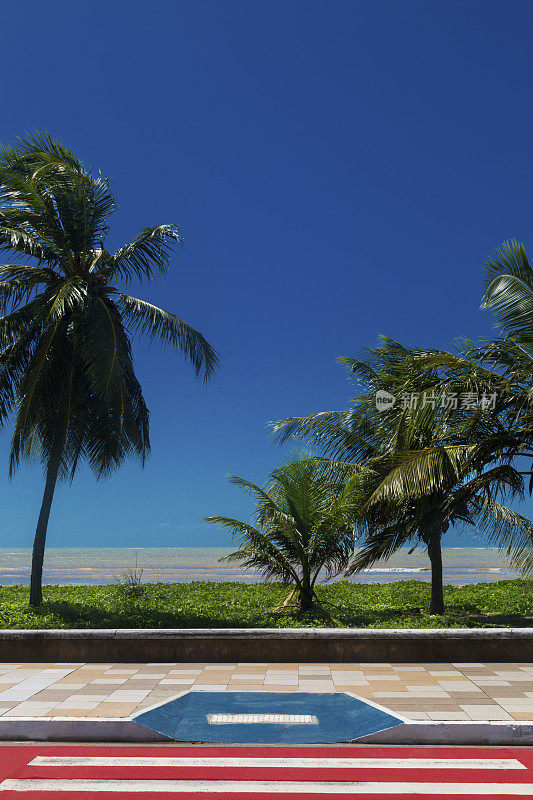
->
[30,756,526,770]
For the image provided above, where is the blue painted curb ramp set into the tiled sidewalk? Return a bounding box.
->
[135,692,403,744]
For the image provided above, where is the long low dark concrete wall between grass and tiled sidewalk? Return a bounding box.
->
[0,628,533,663]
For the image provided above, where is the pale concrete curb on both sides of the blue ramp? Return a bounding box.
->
[0,717,533,745]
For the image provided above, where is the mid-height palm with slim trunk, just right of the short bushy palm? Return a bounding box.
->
[275,337,533,614]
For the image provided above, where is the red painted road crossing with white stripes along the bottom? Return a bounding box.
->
[0,745,533,800]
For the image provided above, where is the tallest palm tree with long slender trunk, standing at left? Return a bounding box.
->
[0,134,217,605]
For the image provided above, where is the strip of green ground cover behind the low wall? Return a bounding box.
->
[0,580,533,628]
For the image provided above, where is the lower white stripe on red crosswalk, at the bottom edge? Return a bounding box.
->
[0,778,533,797]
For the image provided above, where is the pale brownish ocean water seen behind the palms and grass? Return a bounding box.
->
[0,547,519,586]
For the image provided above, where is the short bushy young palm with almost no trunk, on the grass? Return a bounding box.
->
[206,457,355,613]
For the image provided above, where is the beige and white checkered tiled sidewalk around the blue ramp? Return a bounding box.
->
[0,663,533,722]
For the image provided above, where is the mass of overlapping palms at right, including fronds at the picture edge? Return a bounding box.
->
[262,240,533,614]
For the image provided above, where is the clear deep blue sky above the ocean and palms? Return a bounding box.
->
[0,0,533,547]
